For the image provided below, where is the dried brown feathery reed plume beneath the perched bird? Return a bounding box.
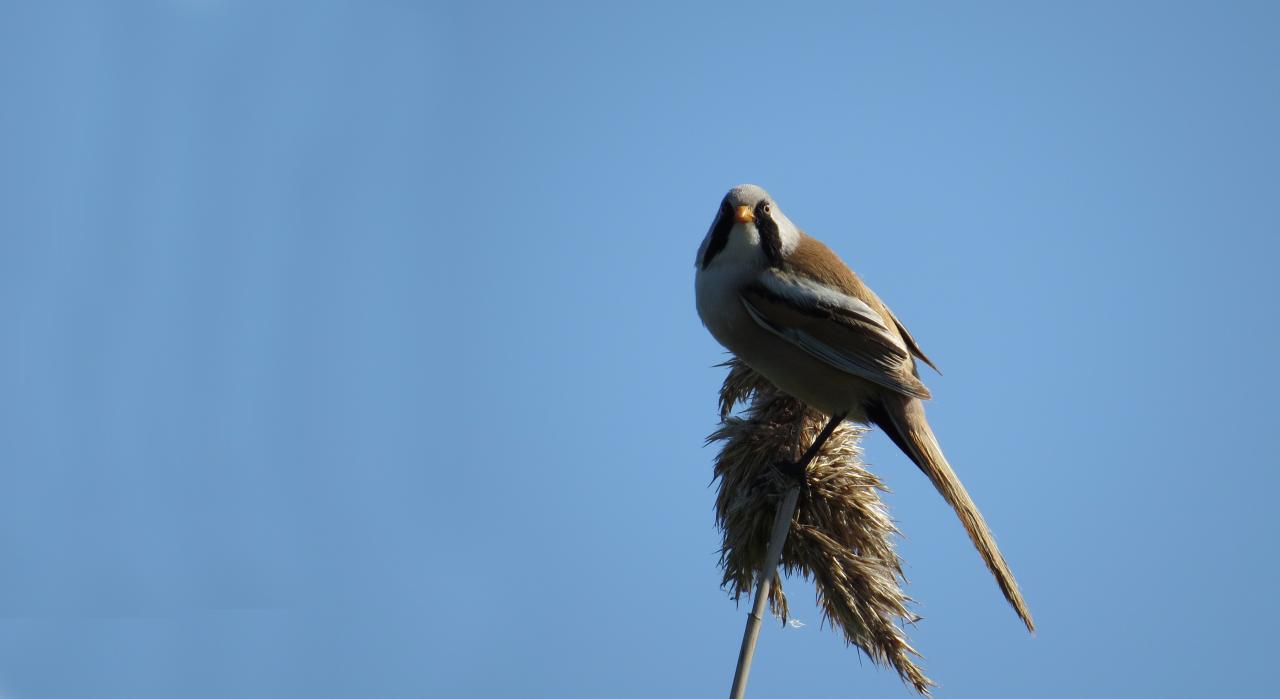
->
[708,358,933,695]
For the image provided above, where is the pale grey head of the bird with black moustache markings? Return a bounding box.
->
[698,184,800,269]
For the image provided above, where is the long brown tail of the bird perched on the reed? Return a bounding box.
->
[868,396,1036,632]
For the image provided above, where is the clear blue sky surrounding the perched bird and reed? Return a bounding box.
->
[0,0,1280,699]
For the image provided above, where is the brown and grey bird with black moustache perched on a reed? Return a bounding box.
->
[694,184,1036,632]
